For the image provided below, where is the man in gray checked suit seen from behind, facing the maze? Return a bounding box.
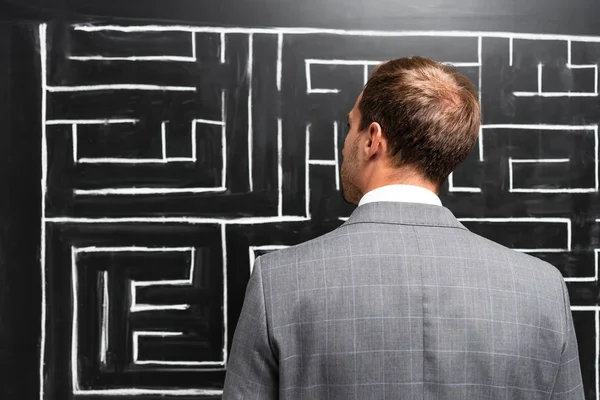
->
[223,57,583,399]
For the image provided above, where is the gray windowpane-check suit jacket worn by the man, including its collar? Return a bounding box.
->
[223,202,583,400]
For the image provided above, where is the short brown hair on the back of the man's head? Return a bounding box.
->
[358,57,481,185]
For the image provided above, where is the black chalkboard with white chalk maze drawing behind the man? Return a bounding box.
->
[0,0,600,399]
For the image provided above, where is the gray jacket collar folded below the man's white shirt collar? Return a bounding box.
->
[344,202,466,229]
